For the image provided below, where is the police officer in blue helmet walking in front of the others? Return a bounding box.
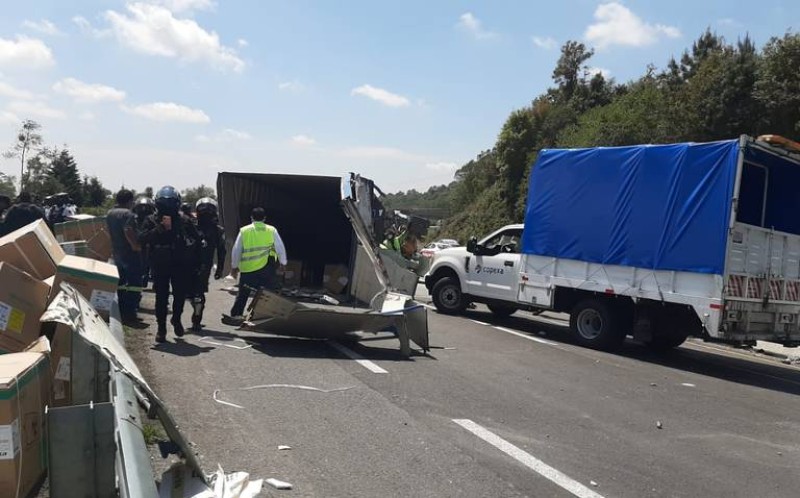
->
[142,185,201,342]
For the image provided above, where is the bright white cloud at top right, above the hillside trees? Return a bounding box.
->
[585,2,681,50]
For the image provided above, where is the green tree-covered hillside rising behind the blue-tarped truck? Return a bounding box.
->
[386,30,800,242]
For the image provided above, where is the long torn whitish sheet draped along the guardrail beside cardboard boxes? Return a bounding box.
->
[41,283,260,490]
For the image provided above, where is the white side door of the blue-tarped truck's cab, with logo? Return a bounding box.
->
[467,229,522,301]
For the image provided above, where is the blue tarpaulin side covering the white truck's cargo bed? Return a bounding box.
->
[522,140,739,275]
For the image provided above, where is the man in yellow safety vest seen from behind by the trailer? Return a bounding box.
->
[225,207,287,321]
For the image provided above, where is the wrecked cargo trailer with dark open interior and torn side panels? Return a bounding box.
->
[217,173,429,356]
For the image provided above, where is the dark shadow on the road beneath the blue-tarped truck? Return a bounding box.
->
[465,311,800,395]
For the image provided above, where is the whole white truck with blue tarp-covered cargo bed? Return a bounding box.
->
[425,137,800,349]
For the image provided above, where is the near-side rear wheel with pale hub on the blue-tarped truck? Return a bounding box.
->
[569,299,625,350]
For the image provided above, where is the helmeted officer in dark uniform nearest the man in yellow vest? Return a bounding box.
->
[192,197,226,332]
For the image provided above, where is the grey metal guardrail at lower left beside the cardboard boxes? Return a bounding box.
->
[47,301,158,498]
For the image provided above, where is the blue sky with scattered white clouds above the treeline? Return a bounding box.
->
[0,0,800,191]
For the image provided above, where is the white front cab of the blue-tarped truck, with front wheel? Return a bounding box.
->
[425,224,526,316]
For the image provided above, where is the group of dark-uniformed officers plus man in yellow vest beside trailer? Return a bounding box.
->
[106,186,287,343]
